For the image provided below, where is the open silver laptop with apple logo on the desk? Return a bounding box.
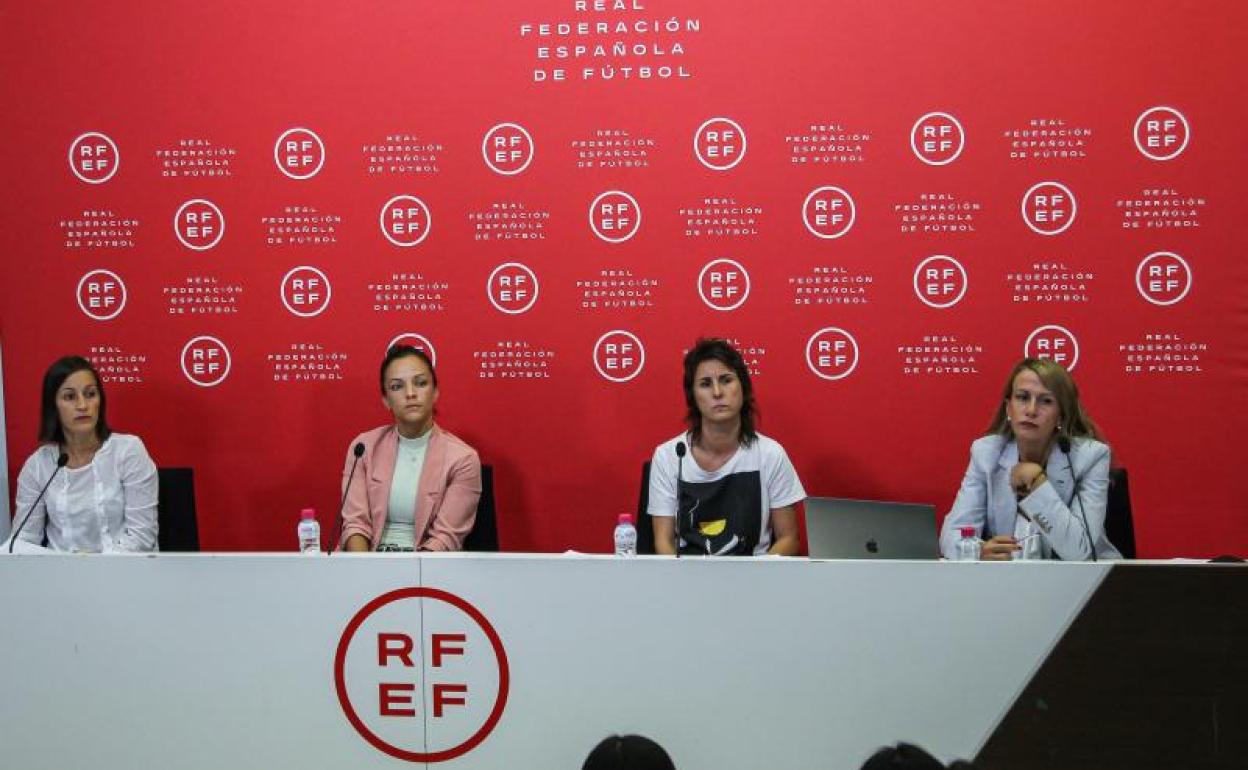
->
[806,497,940,559]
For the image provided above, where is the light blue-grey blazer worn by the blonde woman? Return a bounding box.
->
[940,436,1122,562]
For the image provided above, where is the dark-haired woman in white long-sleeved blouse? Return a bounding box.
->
[15,356,157,553]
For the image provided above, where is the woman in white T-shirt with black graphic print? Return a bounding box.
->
[649,338,806,555]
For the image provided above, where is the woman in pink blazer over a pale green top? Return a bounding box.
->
[342,344,480,550]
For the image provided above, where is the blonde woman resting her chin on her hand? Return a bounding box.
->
[941,358,1122,560]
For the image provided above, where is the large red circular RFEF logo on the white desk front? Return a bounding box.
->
[333,588,510,763]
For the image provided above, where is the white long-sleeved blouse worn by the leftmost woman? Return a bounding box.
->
[12,433,157,553]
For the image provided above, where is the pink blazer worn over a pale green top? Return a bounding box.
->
[338,424,480,550]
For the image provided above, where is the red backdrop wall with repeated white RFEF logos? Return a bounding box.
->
[0,0,1248,557]
